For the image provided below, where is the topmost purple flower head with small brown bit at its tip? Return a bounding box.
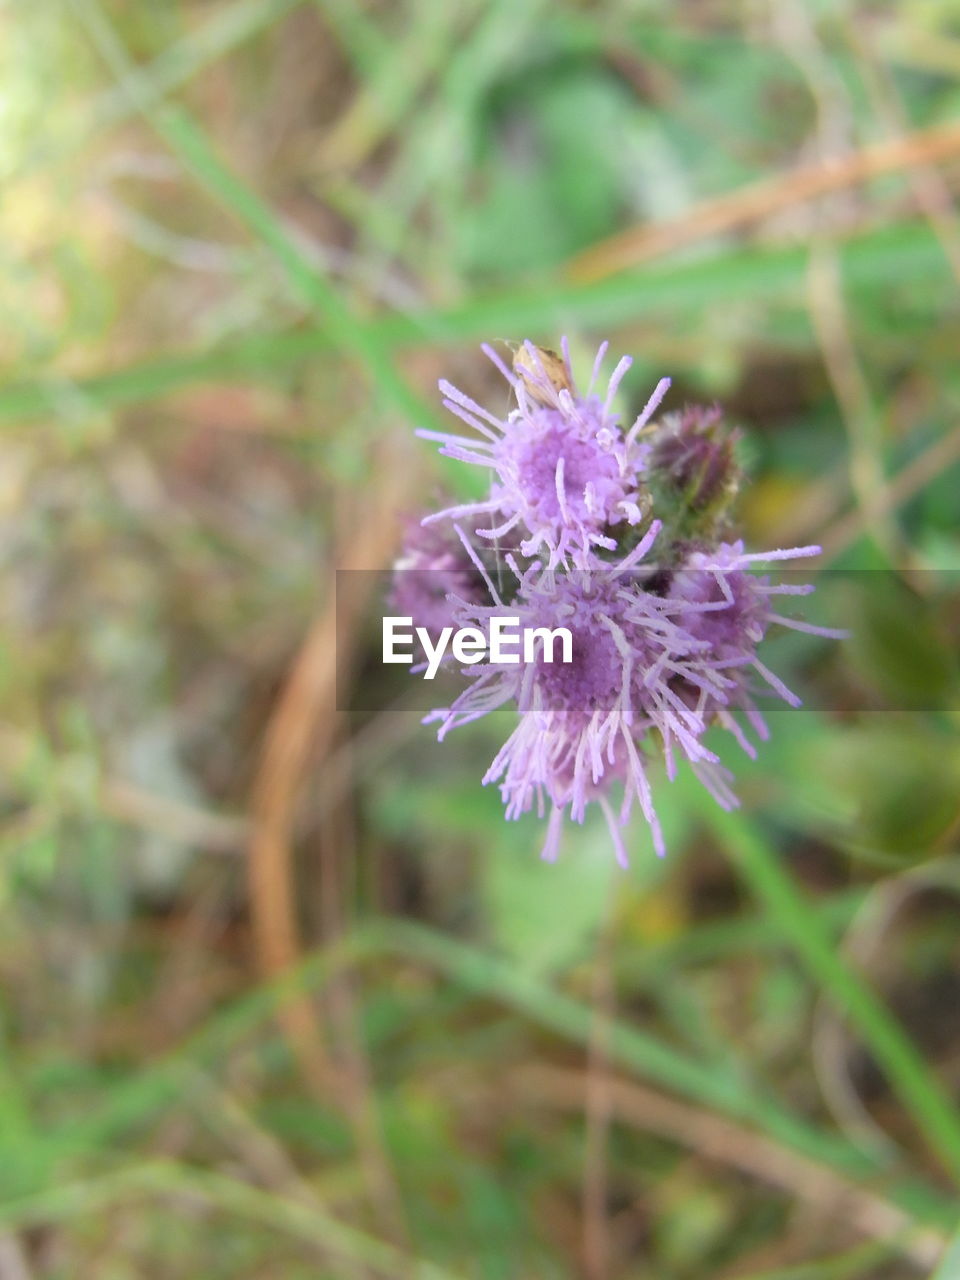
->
[417,338,669,568]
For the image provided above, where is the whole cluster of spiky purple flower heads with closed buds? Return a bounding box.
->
[394,342,837,864]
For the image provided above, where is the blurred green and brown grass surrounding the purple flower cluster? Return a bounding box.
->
[0,0,960,1280]
